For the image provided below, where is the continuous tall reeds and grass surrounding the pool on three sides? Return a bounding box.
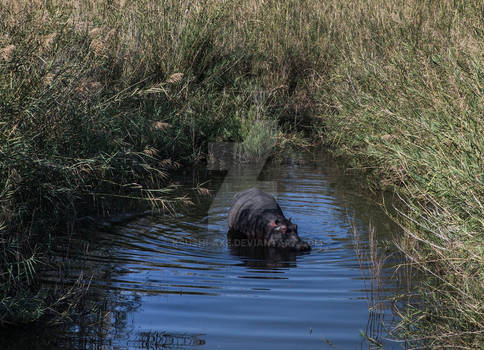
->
[0,0,484,348]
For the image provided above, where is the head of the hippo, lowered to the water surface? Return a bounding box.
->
[264,219,311,251]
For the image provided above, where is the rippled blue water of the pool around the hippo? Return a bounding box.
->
[4,155,412,350]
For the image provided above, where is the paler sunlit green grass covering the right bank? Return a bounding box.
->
[323,1,484,349]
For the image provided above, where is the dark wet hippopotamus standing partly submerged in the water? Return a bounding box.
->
[229,188,311,251]
